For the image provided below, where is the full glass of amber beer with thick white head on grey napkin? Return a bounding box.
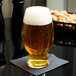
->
[22,6,54,68]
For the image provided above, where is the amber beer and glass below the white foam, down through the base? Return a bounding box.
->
[22,7,54,68]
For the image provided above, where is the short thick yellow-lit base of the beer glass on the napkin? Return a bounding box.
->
[27,55,49,68]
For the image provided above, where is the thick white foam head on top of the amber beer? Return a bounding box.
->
[23,6,52,25]
